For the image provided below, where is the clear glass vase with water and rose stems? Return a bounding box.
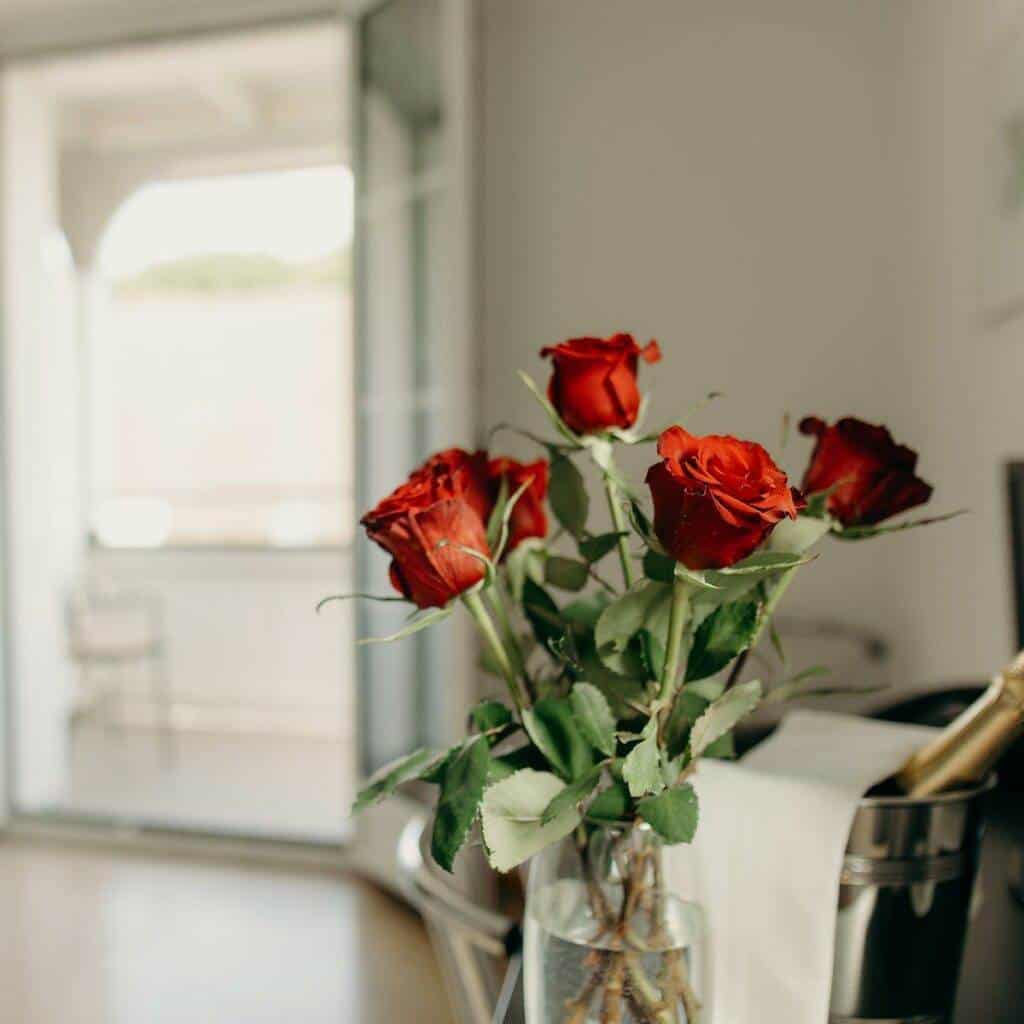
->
[523,823,709,1024]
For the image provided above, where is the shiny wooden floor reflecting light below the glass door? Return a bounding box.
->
[0,840,452,1024]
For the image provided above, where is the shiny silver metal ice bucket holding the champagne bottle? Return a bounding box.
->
[828,778,995,1024]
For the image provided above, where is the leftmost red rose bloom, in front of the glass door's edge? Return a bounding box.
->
[359,449,490,608]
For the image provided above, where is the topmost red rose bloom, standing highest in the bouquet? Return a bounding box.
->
[541,334,662,434]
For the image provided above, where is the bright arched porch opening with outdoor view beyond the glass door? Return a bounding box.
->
[90,167,353,547]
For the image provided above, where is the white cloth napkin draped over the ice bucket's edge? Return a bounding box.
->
[667,711,935,1024]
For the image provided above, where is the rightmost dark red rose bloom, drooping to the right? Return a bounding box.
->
[800,416,932,526]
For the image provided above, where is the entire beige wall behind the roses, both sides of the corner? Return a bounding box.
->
[481,0,1024,685]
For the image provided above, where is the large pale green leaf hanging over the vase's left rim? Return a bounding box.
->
[480,768,581,871]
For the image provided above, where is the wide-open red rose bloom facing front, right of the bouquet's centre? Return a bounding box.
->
[646,427,804,569]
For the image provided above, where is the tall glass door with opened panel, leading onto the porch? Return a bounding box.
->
[0,0,473,844]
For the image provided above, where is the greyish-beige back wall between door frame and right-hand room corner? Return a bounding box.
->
[482,0,929,688]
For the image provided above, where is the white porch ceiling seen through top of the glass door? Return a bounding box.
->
[37,23,349,159]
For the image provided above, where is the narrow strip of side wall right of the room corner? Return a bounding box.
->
[902,0,1024,679]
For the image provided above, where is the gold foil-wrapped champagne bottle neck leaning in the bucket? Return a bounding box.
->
[896,651,1024,797]
